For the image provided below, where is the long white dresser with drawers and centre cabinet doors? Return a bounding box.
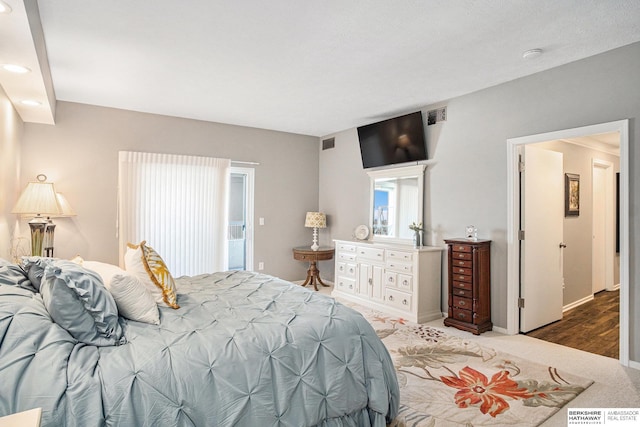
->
[331,240,443,323]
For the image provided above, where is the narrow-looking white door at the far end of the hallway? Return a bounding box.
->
[591,165,607,294]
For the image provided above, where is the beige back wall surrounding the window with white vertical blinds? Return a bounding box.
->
[21,102,319,280]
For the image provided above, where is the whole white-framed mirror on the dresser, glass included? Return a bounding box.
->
[368,165,424,243]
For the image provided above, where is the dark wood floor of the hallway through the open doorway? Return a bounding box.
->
[526,291,620,359]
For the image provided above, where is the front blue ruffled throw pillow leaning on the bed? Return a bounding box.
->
[40,260,126,346]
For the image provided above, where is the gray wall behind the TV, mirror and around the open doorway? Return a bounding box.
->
[320,43,640,361]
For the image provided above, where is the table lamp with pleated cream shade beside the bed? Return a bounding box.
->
[11,177,61,256]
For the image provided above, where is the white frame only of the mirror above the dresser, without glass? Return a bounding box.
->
[367,164,427,244]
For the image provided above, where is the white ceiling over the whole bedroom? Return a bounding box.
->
[0,0,640,136]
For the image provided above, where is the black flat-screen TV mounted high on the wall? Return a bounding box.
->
[358,111,427,169]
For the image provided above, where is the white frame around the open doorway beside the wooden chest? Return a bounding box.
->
[507,119,630,366]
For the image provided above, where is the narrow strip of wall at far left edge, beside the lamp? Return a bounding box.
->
[0,86,24,260]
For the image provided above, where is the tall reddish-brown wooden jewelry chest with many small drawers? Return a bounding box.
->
[444,239,493,335]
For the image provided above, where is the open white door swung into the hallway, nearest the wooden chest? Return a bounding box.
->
[520,145,564,332]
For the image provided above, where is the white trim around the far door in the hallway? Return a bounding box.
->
[591,157,616,292]
